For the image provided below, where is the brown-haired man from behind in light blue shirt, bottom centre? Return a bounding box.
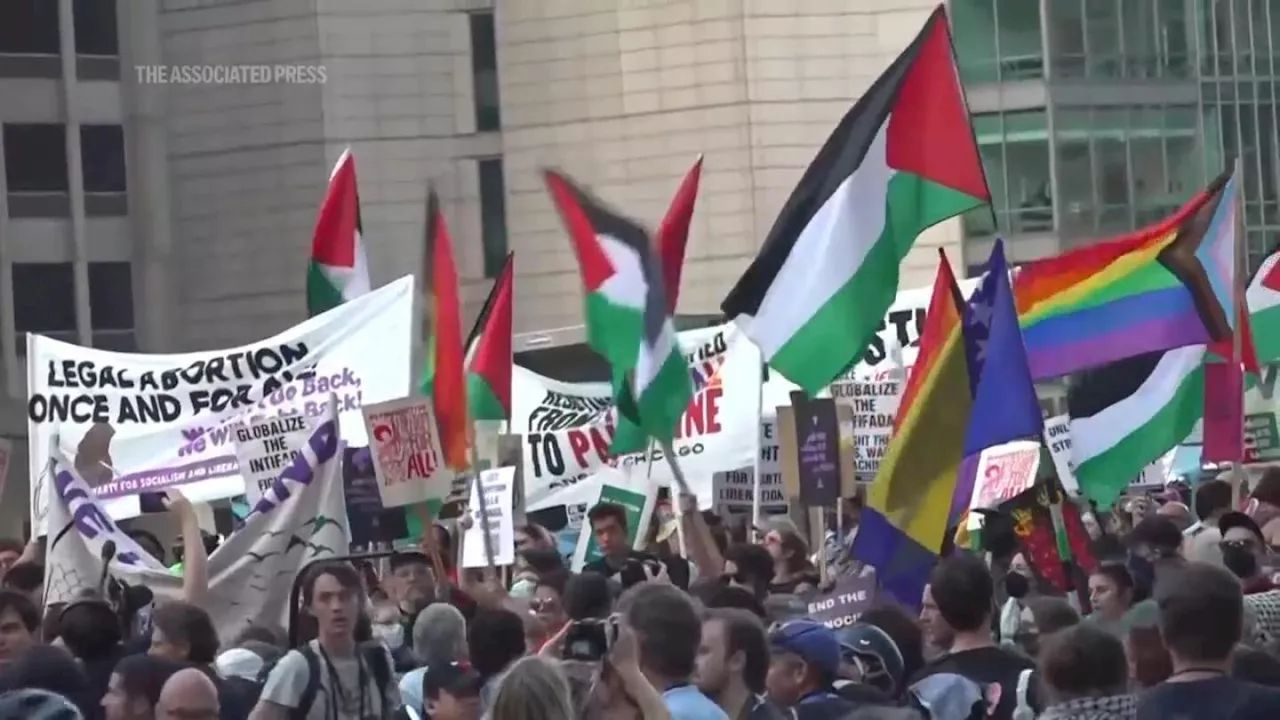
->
[618,583,727,720]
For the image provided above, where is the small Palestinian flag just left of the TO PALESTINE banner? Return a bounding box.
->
[466,252,515,420]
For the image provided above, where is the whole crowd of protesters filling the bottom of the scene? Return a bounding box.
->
[0,470,1280,720]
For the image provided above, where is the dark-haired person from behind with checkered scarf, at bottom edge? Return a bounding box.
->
[1039,625,1138,720]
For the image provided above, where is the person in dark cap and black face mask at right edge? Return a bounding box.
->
[1217,512,1280,643]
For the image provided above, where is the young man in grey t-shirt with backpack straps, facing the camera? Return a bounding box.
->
[251,561,401,720]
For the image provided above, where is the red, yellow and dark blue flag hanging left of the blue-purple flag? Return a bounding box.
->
[852,252,973,607]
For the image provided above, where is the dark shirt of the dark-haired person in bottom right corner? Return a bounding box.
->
[1138,676,1280,720]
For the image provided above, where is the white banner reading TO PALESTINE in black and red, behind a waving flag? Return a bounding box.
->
[511,324,760,510]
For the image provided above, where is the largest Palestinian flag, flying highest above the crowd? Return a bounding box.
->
[721,5,991,395]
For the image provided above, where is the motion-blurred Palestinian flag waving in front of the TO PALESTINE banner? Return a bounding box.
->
[545,172,692,443]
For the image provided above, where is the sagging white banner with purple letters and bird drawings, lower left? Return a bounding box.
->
[45,404,349,638]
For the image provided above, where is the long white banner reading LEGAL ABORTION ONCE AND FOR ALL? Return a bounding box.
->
[27,277,416,533]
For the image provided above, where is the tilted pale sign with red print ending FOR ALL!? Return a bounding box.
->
[364,397,455,507]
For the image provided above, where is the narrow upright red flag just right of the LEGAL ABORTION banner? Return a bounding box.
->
[421,190,471,471]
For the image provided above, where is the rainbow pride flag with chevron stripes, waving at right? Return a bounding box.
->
[1014,176,1239,379]
